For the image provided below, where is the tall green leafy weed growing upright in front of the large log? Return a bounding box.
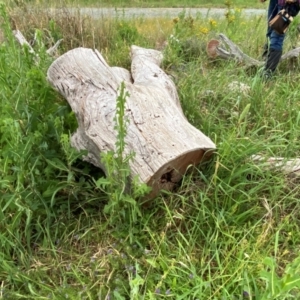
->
[96,82,149,238]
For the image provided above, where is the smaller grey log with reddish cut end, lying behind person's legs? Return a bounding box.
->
[207,33,300,67]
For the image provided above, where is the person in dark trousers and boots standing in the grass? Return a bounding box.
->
[260,0,300,78]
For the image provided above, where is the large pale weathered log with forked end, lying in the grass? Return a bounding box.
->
[47,46,215,196]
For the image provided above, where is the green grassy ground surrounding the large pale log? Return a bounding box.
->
[0,1,300,300]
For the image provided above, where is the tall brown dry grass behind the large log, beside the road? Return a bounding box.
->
[10,8,114,51]
